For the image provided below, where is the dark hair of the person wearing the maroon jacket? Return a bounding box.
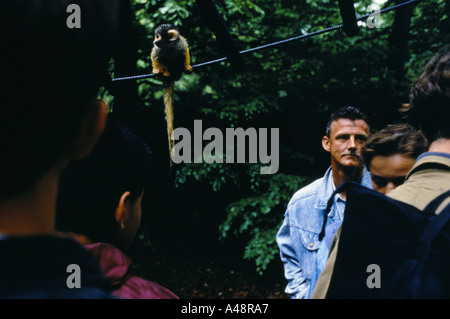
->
[56,121,151,248]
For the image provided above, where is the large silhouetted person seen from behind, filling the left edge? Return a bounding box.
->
[0,0,120,299]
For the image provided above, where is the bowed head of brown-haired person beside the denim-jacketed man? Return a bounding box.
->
[362,124,428,194]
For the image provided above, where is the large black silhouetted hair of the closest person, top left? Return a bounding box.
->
[0,0,120,200]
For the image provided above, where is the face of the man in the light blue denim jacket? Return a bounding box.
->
[322,119,369,169]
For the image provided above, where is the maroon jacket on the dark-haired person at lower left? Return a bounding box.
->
[85,242,179,299]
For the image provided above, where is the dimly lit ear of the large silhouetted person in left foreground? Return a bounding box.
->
[66,100,108,160]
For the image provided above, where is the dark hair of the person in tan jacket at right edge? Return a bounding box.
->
[407,51,450,143]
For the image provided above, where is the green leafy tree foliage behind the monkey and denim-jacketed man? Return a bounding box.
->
[128,0,450,273]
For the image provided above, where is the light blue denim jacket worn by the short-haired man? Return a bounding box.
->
[277,167,372,299]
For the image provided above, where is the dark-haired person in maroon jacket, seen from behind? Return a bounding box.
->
[56,121,178,299]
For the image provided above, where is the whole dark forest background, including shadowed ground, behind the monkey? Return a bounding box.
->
[101,0,450,298]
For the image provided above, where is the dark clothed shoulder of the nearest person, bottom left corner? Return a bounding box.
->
[0,235,116,299]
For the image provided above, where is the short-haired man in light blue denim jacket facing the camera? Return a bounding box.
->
[277,106,371,299]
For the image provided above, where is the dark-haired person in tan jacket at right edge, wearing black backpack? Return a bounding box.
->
[312,51,450,299]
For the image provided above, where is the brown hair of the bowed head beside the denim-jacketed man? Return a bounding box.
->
[362,124,428,168]
